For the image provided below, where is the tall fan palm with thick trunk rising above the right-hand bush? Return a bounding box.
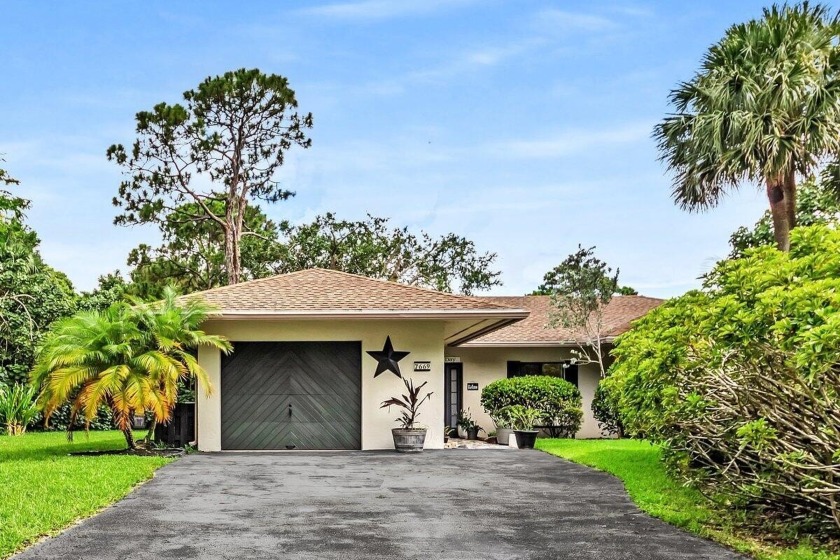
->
[654,2,840,251]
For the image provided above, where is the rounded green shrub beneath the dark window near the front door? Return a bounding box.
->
[481,375,583,437]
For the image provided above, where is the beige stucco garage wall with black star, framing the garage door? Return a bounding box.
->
[196,319,444,451]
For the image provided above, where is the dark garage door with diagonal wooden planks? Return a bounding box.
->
[222,342,362,449]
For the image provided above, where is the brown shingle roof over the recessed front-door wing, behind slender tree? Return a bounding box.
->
[460,296,664,346]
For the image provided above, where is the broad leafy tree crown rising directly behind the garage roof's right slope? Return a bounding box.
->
[279,213,501,294]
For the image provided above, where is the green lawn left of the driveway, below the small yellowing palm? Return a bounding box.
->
[0,431,169,559]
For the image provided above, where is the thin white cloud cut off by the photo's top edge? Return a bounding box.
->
[297,0,472,21]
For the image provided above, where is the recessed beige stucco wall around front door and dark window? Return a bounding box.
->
[446,347,602,438]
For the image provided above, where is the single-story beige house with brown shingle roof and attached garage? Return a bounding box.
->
[186,269,659,451]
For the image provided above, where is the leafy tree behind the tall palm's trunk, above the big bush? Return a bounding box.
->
[729,176,840,258]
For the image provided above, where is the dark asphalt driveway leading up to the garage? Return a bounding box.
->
[15,450,740,560]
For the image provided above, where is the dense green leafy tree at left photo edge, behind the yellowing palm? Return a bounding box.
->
[0,178,75,385]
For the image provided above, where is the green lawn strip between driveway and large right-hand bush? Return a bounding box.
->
[537,439,840,560]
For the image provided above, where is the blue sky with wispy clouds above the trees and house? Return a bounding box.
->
[0,0,766,296]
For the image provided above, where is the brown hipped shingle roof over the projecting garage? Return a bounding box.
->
[183,268,527,318]
